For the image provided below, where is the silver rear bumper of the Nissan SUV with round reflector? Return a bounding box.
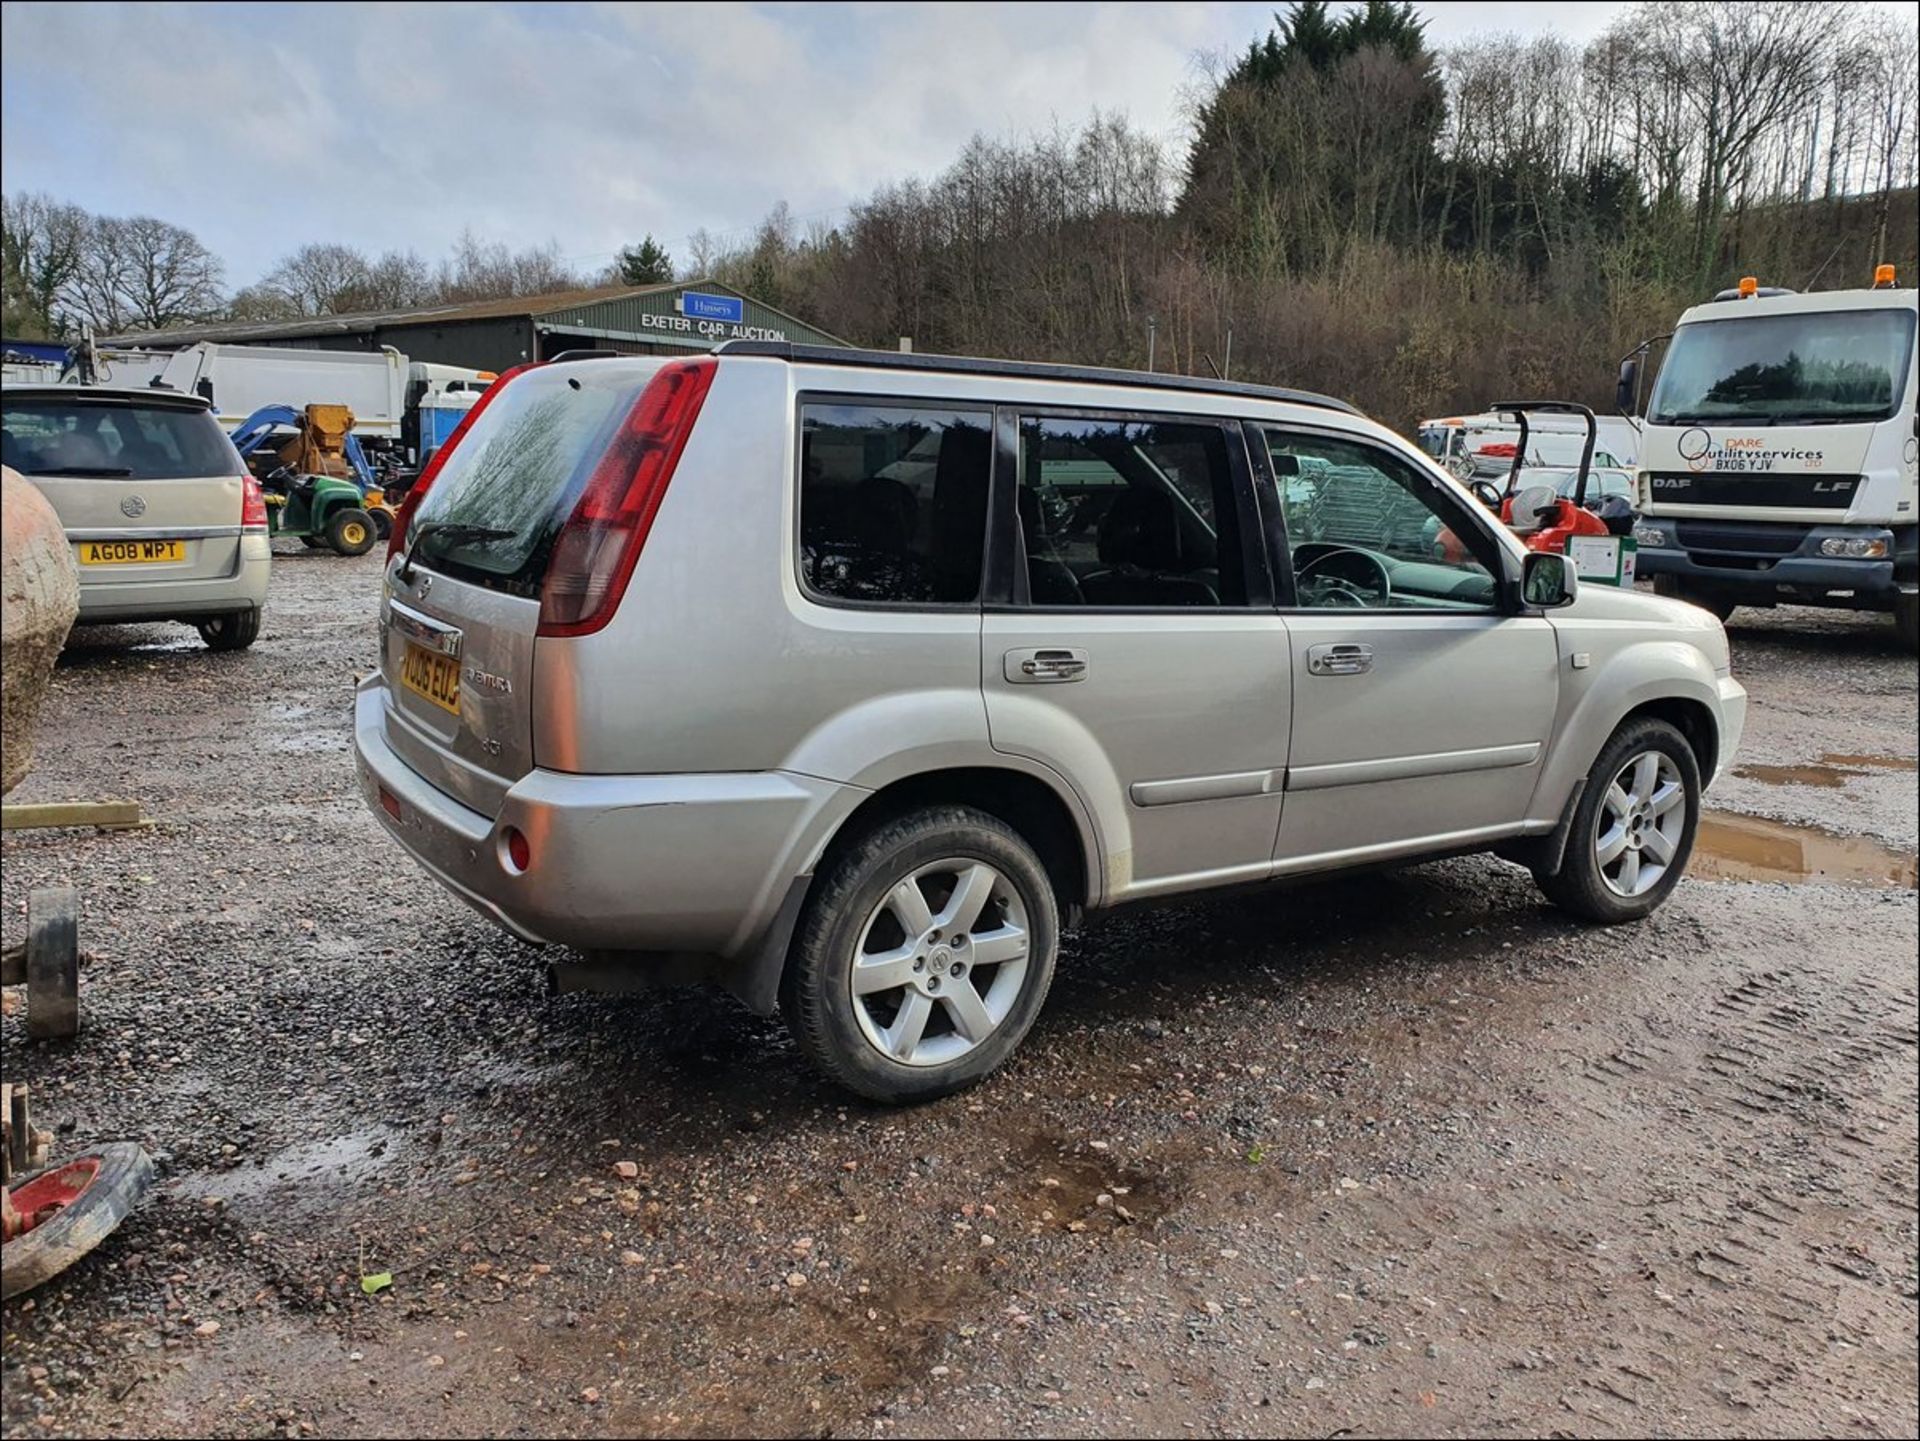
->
[353,673,866,957]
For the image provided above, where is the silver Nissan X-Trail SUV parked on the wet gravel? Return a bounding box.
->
[355,342,1745,1101]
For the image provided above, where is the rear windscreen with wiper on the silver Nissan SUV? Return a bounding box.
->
[409,365,649,593]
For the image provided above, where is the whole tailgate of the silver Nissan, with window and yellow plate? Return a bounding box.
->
[382,359,664,815]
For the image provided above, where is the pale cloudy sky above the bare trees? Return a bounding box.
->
[0,0,1835,286]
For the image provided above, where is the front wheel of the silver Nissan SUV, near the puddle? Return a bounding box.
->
[1534,720,1701,925]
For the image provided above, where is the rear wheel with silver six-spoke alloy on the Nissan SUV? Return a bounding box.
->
[781,806,1060,1105]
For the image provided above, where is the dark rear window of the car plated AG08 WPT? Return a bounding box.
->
[0,395,246,480]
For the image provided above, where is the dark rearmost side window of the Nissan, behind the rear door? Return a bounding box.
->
[801,403,993,604]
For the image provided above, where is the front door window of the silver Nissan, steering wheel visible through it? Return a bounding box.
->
[1265,430,1500,610]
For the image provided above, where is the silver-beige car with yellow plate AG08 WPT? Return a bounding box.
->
[0,384,273,650]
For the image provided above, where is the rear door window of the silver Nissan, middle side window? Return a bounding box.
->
[1020,416,1246,608]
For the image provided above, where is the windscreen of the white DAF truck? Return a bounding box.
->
[1647,309,1914,426]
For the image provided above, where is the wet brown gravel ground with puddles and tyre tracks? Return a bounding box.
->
[0,551,1920,1437]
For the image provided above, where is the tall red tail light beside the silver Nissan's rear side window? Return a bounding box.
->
[540,359,718,635]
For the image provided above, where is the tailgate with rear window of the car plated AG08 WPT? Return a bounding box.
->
[4,386,246,587]
